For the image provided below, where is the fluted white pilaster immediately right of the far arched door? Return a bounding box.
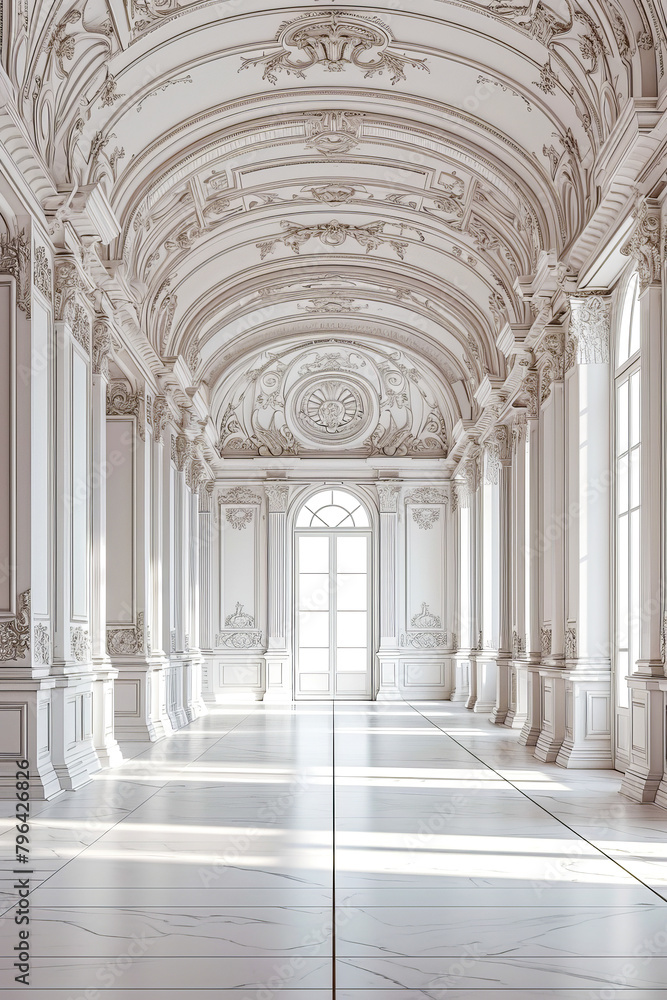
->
[374,483,401,701]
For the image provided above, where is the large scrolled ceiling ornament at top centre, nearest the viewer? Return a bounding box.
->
[239,10,430,84]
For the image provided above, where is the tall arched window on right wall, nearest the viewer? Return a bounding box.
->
[614,275,641,708]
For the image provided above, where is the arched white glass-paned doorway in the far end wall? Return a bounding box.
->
[294,489,373,700]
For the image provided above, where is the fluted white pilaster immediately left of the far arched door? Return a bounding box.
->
[264,483,293,702]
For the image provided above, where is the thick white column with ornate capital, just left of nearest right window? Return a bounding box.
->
[556,295,614,768]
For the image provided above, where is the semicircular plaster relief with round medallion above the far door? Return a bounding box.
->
[218,342,447,457]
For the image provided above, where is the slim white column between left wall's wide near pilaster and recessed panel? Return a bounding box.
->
[90,316,123,767]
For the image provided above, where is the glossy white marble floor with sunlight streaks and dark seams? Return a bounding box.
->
[0,703,667,1000]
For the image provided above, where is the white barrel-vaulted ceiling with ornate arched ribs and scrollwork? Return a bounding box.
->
[5,0,667,454]
